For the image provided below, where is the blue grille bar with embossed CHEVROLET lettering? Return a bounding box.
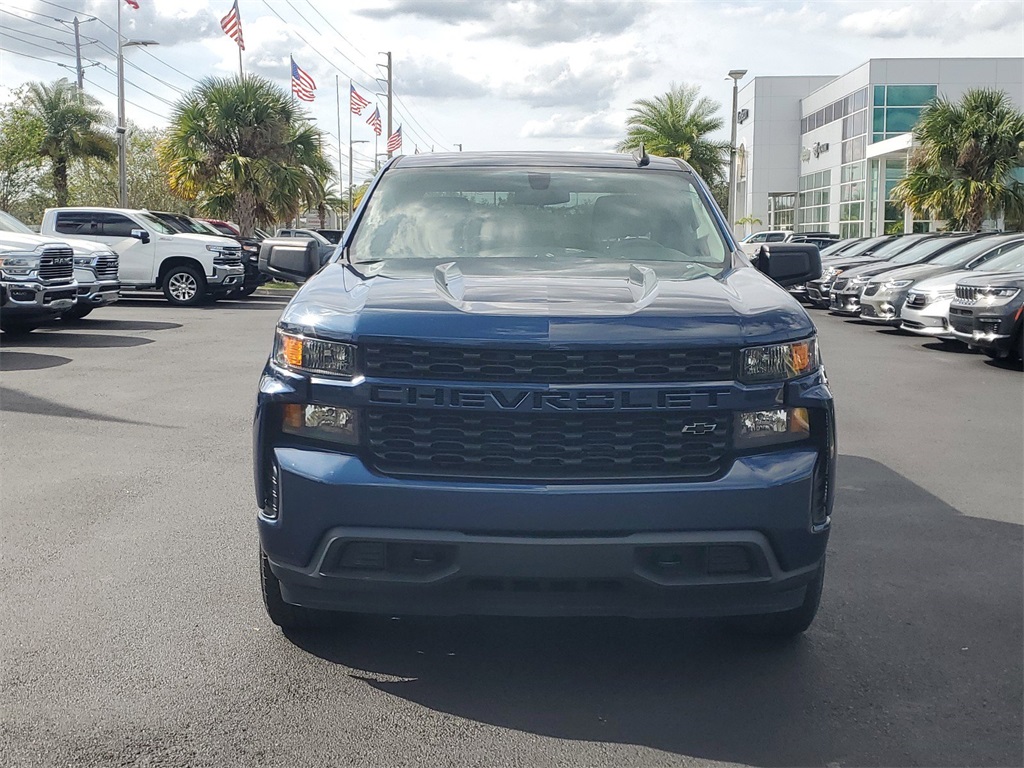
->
[370,384,729,411]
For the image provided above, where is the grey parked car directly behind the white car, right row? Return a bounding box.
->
[860,233,1020,326]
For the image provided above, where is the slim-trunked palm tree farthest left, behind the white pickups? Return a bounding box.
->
[26,78,117,208]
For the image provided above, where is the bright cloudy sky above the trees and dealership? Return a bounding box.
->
[0,0,1024,185]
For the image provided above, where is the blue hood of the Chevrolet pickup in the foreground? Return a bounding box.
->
[282,258,814,346]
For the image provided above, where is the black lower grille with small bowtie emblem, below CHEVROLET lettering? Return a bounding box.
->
[367,408,731,480]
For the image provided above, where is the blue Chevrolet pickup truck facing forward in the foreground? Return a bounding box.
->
[254,151,836,635]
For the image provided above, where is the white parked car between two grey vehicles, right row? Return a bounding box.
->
[900,239,1024,339]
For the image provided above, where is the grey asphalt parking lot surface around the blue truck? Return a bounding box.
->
[0,297,1024,767]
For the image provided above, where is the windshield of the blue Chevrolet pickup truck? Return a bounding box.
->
[350,167,729,276]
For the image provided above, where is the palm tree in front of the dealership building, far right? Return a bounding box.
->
[892,88,1024,231]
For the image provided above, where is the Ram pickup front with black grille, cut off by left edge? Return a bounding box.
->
[0,230,78,334]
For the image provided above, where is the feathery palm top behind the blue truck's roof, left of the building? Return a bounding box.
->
[617,83,729,185]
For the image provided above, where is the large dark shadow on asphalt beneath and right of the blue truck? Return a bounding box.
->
[288,456,1024,766]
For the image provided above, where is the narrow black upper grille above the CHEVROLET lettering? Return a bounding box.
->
[364,343,735,384]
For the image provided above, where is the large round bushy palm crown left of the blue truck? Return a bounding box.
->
[157,75,332,236]
